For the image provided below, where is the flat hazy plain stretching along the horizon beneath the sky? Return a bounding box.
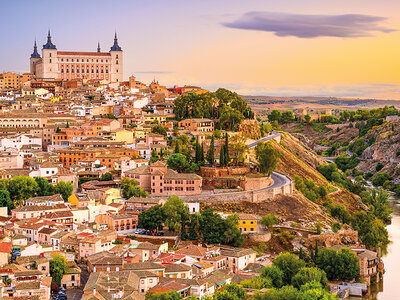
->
[242,96,400,111]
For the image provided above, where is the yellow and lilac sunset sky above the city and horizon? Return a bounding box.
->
[0,0,400,99]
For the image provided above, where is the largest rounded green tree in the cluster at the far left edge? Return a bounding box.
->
[8,176,39,205]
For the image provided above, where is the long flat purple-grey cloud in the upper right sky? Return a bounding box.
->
[222,12,396,38]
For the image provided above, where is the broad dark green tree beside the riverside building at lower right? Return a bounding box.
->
[315,248,360,280]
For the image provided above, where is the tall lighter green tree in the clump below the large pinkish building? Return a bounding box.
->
[163,196,189,232]
